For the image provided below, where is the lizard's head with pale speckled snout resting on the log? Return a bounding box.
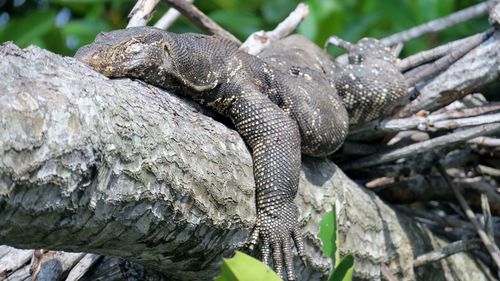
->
[75,27,174,81]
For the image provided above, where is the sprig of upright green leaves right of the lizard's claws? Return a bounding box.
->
[318,206,354,281]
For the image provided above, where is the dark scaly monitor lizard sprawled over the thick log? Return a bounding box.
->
[75,27,404,280]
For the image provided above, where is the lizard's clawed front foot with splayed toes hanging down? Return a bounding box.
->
[246,202,305,280]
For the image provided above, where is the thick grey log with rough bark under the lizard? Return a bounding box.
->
[0,44,493,280]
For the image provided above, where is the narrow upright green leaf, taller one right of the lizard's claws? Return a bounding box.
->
[318,205,339,268]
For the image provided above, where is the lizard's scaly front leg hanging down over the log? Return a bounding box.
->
[227,87,304,280]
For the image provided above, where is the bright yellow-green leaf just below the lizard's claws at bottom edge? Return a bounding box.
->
[214,251,281,281]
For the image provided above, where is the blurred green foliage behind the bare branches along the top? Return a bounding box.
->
[0,0,487,56]
